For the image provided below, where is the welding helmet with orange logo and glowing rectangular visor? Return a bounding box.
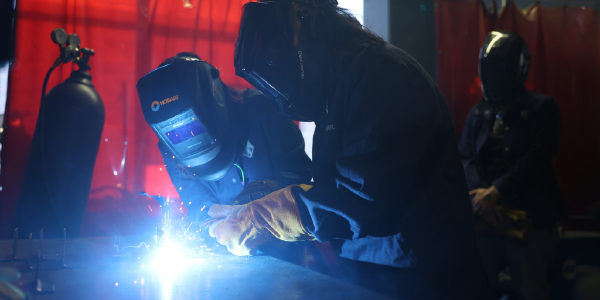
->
[137,57,239,181]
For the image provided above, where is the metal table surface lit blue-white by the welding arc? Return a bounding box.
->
[0,237,396,300]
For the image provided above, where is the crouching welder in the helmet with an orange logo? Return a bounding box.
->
[137,52,311,224]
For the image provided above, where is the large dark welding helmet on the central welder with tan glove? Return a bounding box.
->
[234,0,337,121]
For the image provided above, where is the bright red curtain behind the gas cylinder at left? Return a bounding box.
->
[0,0,249,238]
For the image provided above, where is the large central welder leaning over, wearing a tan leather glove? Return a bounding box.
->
[209,0,490,299]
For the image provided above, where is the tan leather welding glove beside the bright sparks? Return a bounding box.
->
[208,185,315,256]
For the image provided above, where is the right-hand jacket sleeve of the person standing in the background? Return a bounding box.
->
[493,99,560,195]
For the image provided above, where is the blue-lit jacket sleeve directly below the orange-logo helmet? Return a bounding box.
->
[158,142,219,221]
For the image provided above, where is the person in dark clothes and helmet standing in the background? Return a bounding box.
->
[461,31,564,300]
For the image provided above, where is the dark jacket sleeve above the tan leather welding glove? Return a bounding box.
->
[298,57,448,241]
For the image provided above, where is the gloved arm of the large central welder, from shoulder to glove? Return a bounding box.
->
[209,52,468,255]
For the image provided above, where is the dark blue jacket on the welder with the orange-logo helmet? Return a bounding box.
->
[158,92,311,219]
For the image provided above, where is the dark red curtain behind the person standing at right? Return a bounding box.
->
[436,0,600,214]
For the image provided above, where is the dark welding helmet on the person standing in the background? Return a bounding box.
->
[479,31,531,105]
